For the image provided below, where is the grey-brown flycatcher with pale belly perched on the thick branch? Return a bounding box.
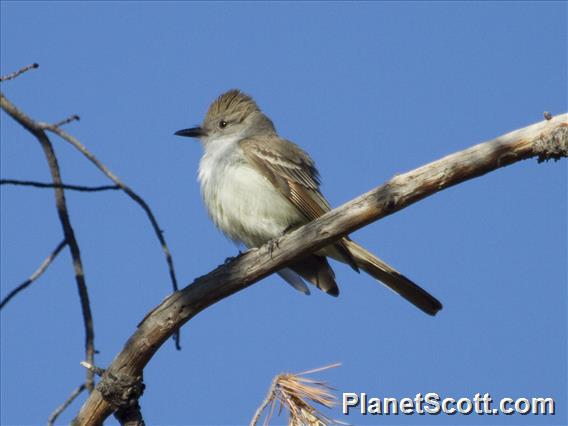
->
[175,90,442,315]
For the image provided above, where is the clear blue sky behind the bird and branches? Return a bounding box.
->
[0,2,568,425]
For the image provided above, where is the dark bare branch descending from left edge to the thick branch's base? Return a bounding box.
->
[0,93,95,391]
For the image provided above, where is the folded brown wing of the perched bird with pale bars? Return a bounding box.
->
[239,135,359,271]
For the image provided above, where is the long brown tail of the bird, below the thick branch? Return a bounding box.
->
[339,238,442,315]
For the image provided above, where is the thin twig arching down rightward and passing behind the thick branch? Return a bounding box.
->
[39,123,181,350]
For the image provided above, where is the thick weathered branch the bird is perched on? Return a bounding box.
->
[74,114,568,425]
